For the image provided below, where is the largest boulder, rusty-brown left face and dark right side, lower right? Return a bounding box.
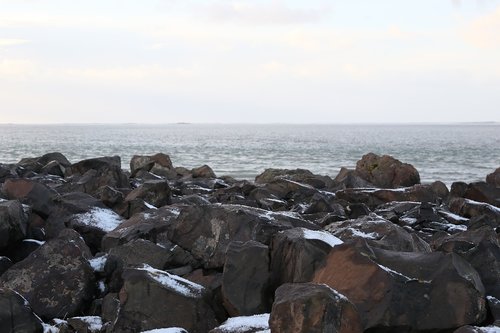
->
[313,244,486,332]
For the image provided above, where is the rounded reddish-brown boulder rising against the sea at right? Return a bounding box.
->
[356,153,420,188]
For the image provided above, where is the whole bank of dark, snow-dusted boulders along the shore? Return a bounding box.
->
[0,153,500,333]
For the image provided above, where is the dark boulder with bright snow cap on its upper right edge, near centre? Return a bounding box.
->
[271,228,342,289]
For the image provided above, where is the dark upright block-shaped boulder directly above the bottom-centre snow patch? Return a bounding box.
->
[222,241,272,317]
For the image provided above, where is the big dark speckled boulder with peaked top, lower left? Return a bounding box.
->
[0,229,94,320]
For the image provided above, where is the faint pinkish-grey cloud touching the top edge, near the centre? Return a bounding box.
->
[198,1,330,25]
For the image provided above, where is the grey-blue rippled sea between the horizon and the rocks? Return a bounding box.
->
[0,124,500,185]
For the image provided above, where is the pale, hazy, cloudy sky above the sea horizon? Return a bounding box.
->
[0,0,500,124]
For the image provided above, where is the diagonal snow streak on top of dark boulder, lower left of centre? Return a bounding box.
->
[137,264,204,298]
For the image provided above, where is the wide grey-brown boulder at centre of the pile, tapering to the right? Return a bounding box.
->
[169,205,318,268]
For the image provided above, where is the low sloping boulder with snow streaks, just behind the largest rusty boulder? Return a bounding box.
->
[325,213,431,252]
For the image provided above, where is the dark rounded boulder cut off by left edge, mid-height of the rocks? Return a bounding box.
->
[0,200,28,250]
